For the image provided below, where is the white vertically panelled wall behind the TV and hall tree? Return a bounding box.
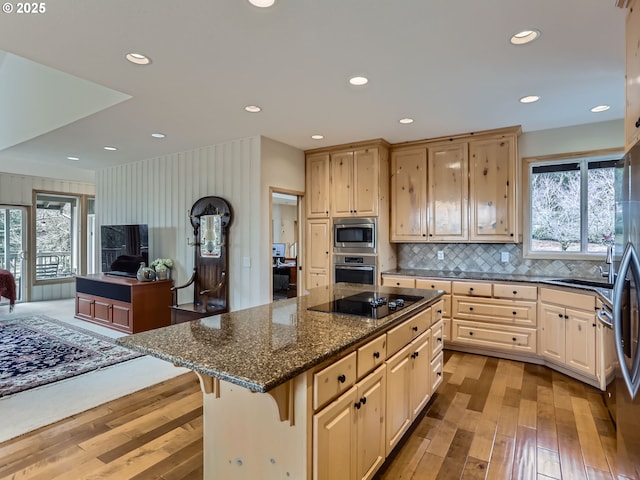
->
[96,137,304,310]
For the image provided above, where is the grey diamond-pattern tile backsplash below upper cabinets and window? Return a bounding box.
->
[398,243,605,278]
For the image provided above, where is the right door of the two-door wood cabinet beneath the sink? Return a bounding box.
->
[566,309,596,375]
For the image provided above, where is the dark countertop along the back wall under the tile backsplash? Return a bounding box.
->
[382,269,613,304]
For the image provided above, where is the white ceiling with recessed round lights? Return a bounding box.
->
[0,0,625,169]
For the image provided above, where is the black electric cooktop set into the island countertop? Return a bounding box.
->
[309,292,424,319]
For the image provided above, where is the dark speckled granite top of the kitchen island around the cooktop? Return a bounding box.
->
[117,284,443,392]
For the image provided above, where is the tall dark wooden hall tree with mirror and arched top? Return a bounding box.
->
[171,197,231,323]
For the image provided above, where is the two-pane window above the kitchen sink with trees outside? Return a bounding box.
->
[525,154,620,258]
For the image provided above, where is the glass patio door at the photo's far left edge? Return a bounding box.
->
[0,205,27,304]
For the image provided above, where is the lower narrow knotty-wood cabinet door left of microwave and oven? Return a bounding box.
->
[305,218,331,288]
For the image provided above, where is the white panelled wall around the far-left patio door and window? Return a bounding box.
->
[0,172,95,301]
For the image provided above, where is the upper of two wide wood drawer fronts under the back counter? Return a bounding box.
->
[453,297,537,327]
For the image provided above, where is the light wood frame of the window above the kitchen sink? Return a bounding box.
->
[522,148,624,261]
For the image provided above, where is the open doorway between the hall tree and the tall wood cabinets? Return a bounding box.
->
[271,189,300,301]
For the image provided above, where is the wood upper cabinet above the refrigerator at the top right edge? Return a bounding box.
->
[624,0,640,151]
